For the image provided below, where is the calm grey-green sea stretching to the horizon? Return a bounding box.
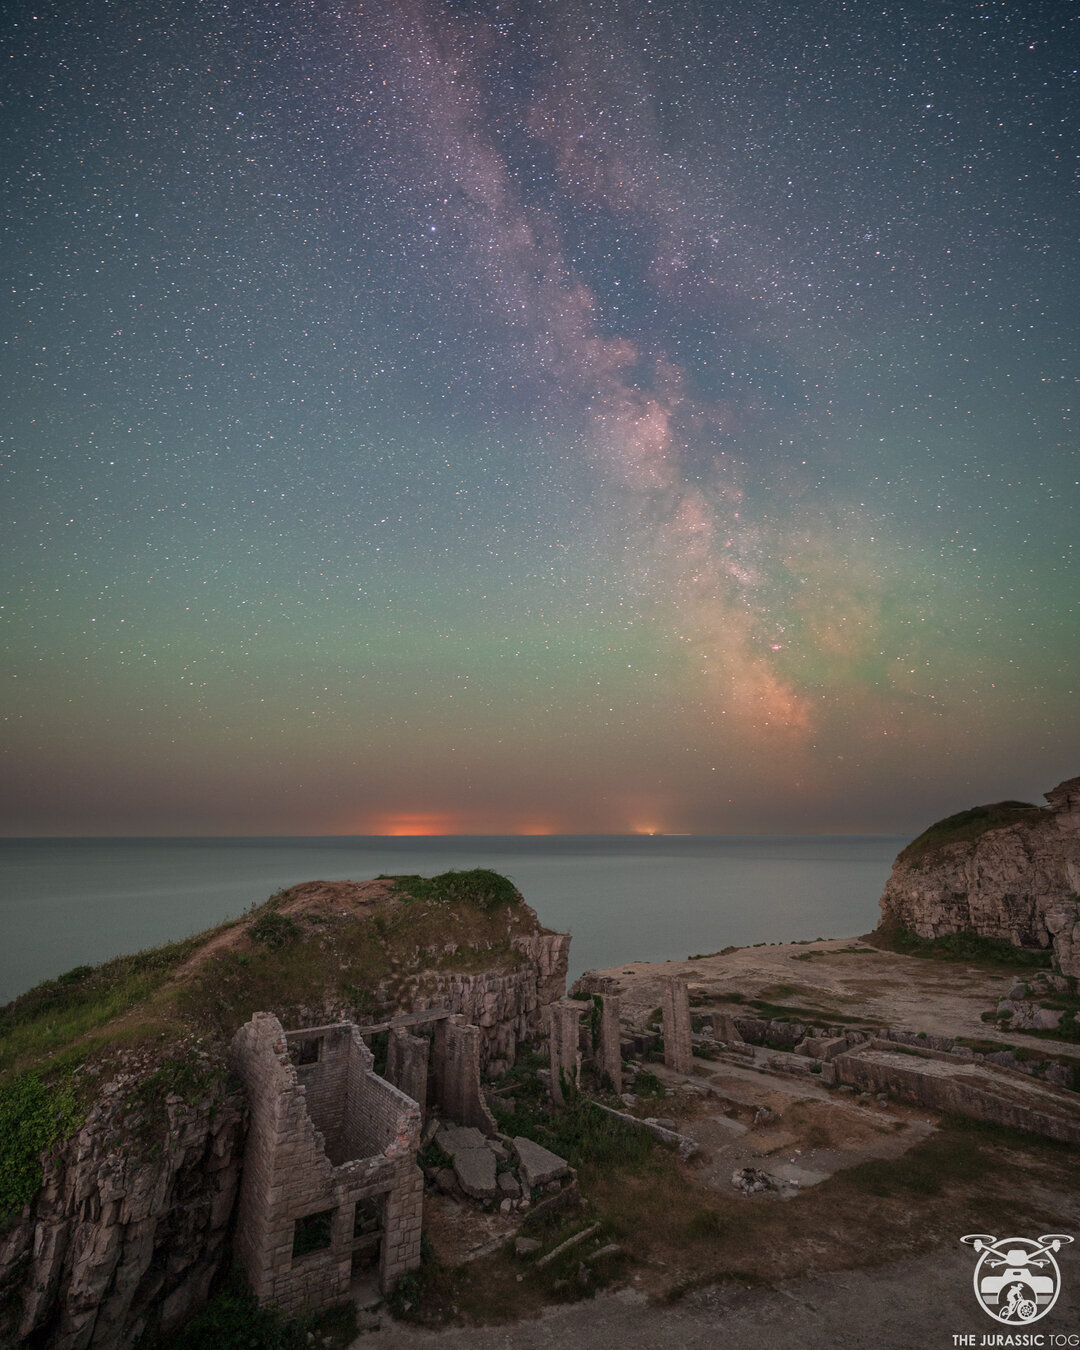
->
[0,834,909,1003]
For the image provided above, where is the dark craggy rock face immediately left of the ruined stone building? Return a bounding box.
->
[0,1056,243,1350]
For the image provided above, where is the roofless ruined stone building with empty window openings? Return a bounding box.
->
[230,1013,424,1316]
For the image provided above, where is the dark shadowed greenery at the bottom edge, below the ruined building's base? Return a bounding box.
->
[139,1272,356,1350]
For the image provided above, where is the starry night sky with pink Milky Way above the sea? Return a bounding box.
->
[0,0,1080,834]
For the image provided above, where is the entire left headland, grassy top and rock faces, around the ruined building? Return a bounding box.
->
[0,871,570,1350]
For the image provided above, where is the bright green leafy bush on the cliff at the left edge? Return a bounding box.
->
[0,1072,82,1215]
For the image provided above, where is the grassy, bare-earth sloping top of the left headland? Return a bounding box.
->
[0,868,541,1076]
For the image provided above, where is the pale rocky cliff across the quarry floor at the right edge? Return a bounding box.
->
[880,778,1080,976]
